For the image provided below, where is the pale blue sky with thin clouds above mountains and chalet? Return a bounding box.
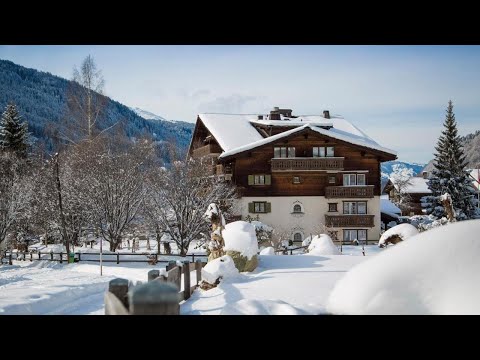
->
[0,45,480,162]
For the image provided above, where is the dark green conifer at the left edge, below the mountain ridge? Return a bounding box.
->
[0,104,28,158]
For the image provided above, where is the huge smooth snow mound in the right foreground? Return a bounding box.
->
[327,220,480,314]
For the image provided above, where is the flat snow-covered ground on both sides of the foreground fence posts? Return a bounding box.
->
[0,245,383,314]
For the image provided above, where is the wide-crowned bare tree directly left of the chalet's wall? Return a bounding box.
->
[145,159,235,255]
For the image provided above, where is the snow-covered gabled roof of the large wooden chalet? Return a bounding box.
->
[198,114,397,158]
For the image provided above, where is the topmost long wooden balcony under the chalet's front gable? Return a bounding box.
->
[272,157,343,171]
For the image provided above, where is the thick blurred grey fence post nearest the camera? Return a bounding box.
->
[128,281,180,315]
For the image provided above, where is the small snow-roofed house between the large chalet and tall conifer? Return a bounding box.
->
[384,171,432,216]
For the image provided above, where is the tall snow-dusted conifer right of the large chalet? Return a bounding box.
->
[425,100,477,220]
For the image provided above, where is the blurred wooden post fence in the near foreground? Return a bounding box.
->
[105,260,206,315]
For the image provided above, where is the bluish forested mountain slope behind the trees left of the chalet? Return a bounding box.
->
[0,60,194,151]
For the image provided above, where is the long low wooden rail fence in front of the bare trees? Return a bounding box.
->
[0,251,207,265]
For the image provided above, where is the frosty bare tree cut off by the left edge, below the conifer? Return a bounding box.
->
[0,152,33,243]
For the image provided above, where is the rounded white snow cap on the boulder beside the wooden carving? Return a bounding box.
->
[222,221,258,259]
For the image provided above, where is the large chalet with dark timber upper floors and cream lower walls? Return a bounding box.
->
[189,108,397,242]
